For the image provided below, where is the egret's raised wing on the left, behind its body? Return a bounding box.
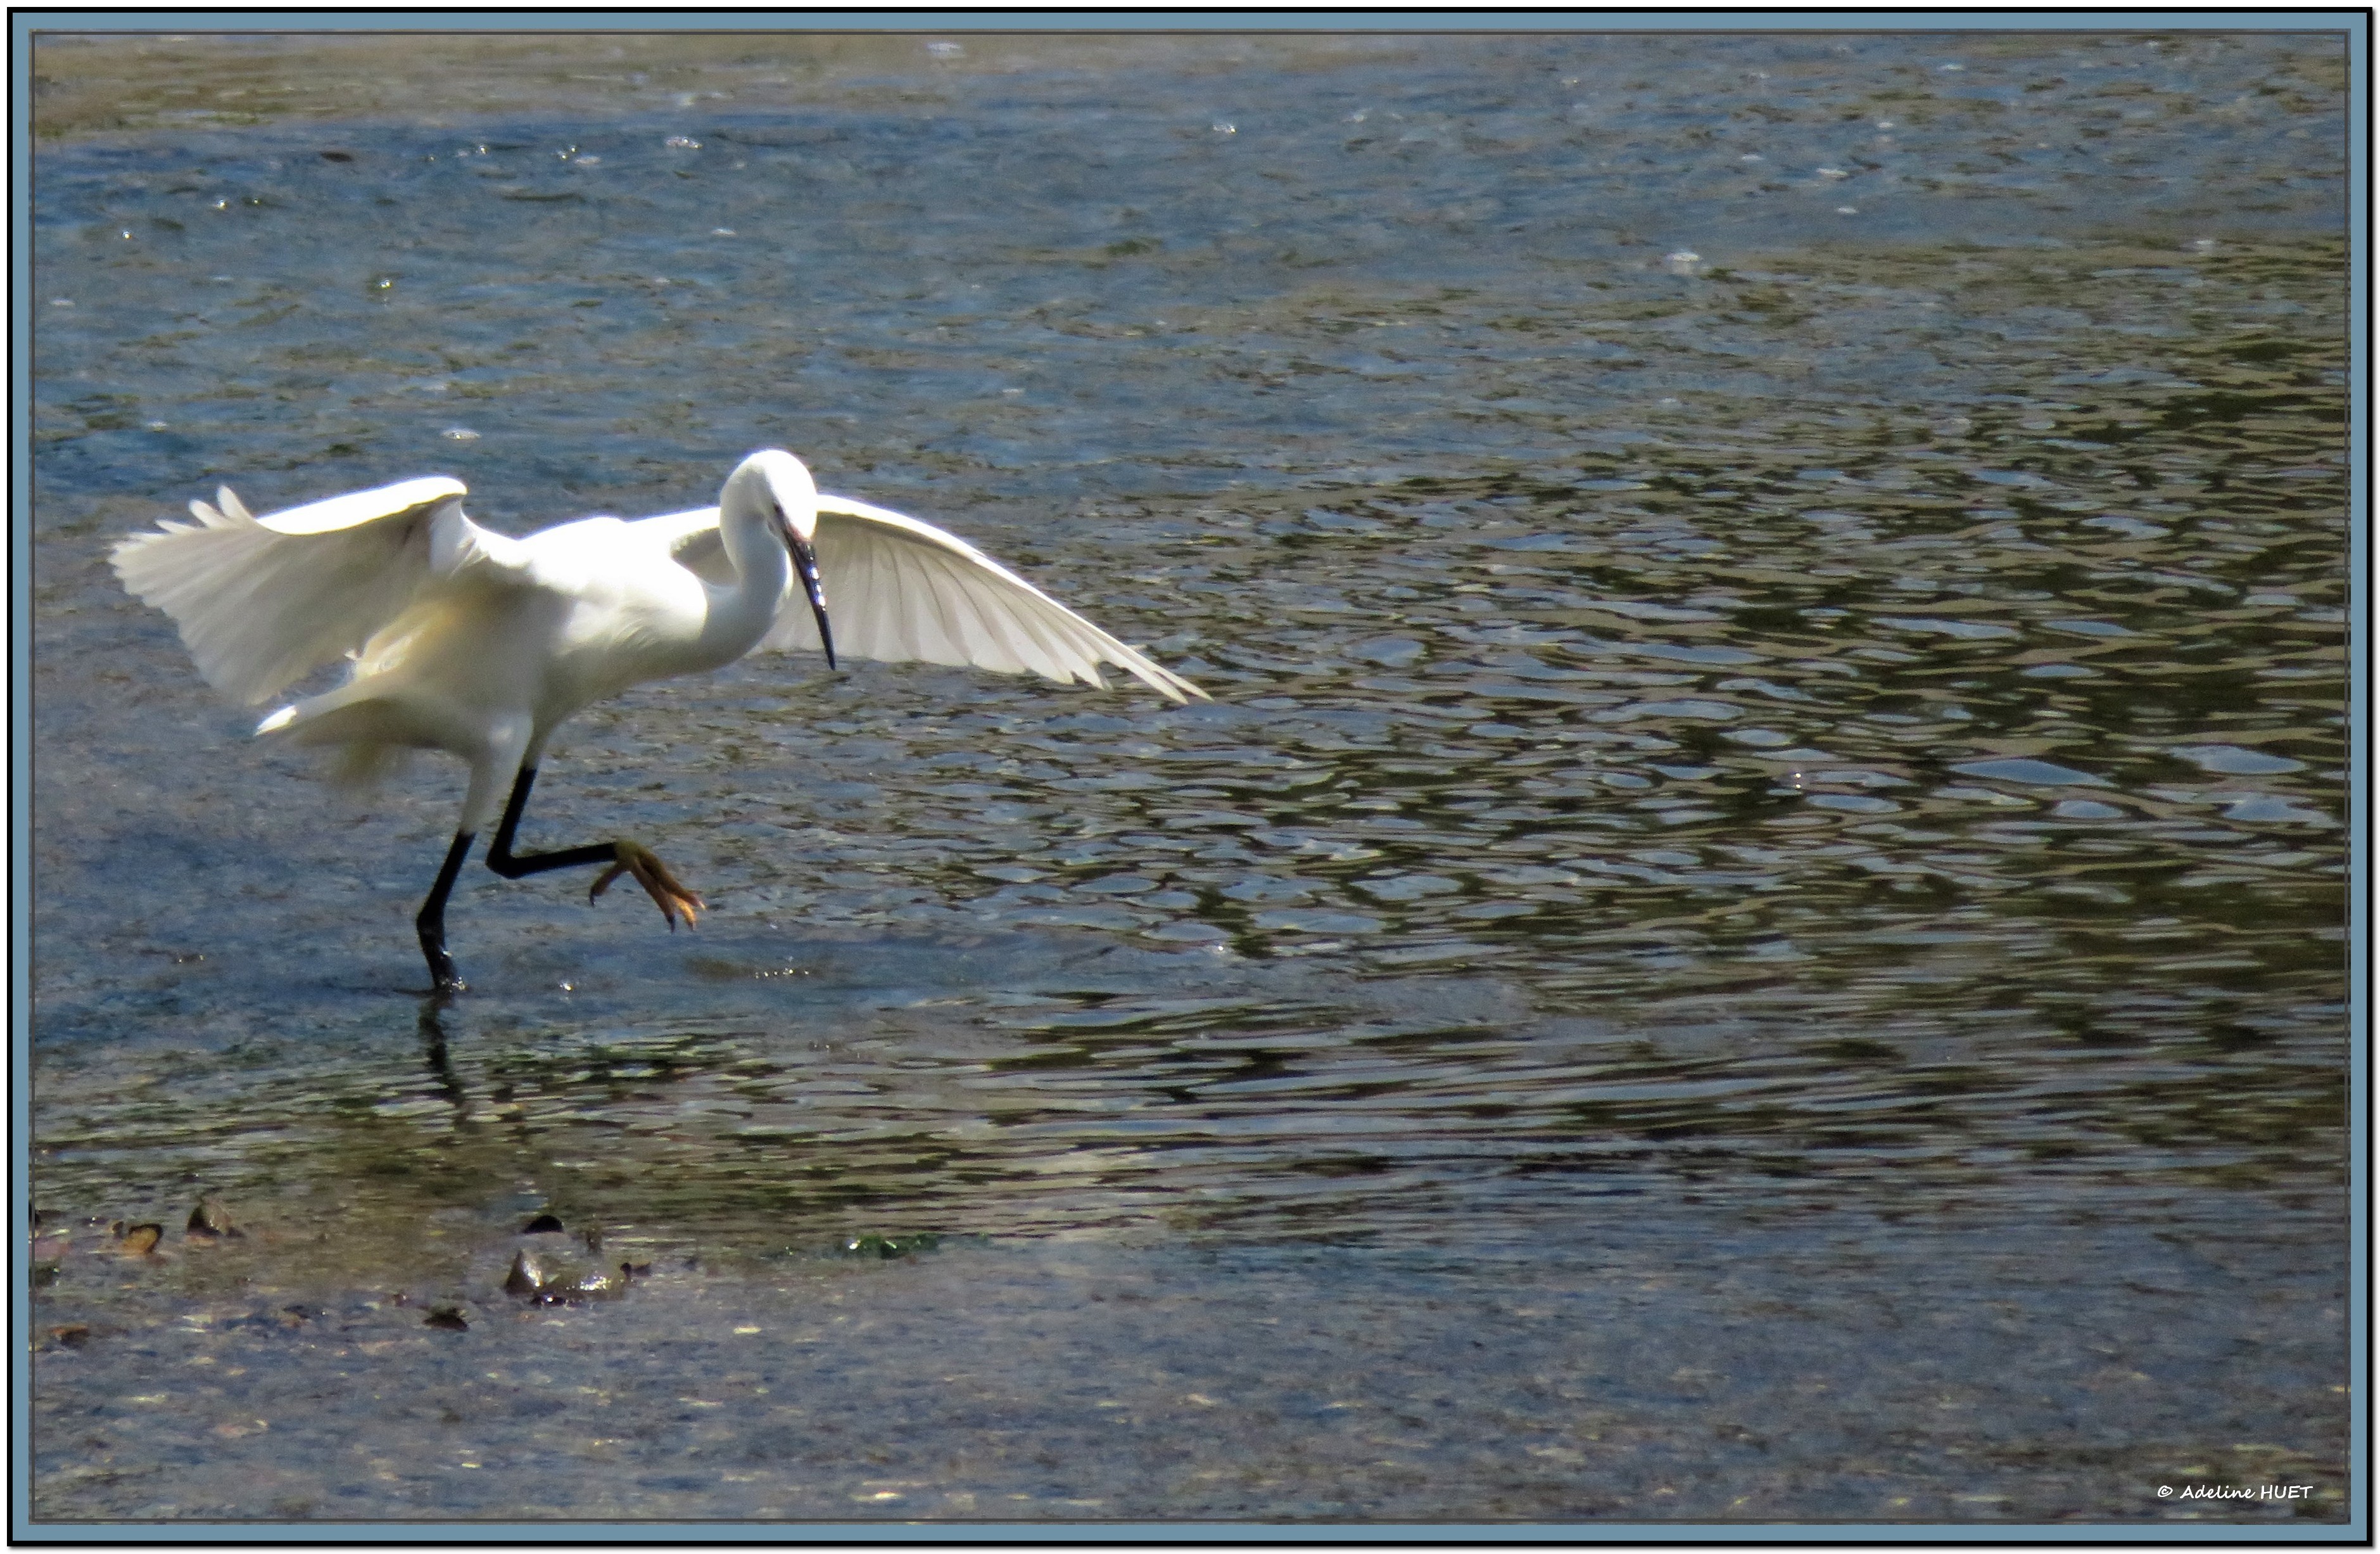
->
[110,476,524,702]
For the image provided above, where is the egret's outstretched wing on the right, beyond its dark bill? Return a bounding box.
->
[790,493,1206,702]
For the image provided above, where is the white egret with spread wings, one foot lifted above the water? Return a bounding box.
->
[114,450,1206,990]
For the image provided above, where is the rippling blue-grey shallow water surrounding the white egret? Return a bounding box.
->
[31,35,2346,1520]
